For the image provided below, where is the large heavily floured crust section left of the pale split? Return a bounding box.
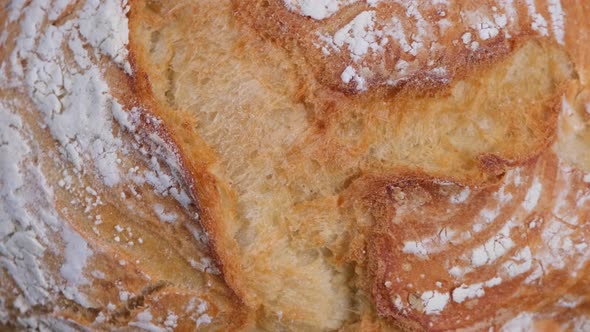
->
[0,1,247,331]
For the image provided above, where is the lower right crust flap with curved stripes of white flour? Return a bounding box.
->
[360,155,590,330]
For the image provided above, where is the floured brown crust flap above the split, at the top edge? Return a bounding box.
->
[234,0,568,94]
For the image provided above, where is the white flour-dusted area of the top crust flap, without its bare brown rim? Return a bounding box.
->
[284,0,566,92]
